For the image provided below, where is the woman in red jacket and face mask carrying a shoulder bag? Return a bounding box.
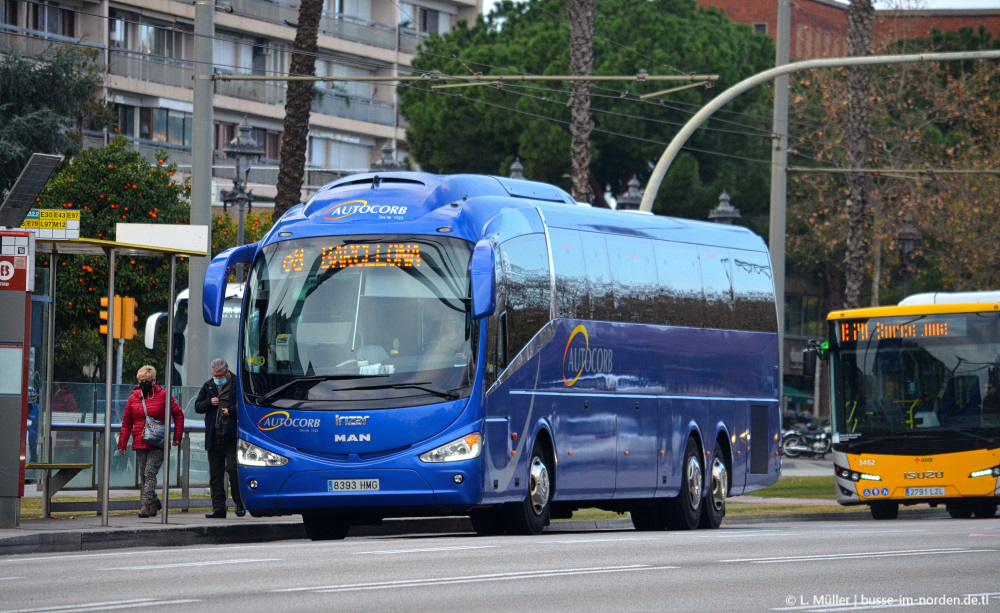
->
[118,366,184,517]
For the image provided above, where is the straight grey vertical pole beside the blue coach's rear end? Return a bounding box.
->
[767,0,792,406]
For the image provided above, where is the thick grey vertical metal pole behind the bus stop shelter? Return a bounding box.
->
[191,0,215,388]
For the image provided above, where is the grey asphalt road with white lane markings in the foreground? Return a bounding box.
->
[0,519,1000,613]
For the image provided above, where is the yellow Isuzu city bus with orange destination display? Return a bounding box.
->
[806,292,1000,519]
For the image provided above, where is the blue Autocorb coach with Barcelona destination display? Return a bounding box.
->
[204,172,780,540]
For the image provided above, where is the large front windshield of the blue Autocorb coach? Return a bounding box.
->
[241,236,477,410]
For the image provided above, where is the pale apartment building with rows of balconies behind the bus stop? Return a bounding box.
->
[0,0,482,207]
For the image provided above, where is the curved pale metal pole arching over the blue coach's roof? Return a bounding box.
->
[639,49,1000,211]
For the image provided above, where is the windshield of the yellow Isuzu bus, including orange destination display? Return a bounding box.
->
[830,313,1000,442]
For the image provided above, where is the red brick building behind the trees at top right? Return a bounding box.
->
[698,0,1000,61]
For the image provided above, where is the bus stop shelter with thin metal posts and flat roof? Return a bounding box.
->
[35,224,209,526]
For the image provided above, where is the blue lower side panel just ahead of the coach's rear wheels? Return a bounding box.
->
[615,396,660,498]
